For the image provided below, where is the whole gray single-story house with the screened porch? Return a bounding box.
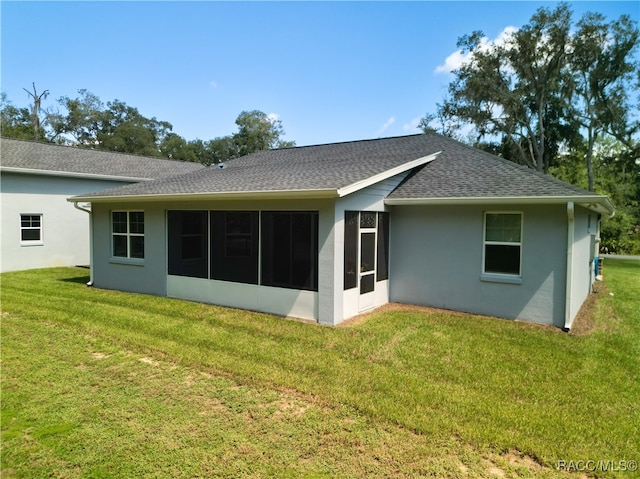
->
[69,134,613,329]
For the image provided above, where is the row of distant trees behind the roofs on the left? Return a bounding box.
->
[0,84,295,165]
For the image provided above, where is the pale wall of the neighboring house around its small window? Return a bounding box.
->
[0,172,127,271]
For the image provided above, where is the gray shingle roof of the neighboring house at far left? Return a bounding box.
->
[0,138,204,181]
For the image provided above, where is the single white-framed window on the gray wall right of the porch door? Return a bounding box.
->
[484,212,522,276]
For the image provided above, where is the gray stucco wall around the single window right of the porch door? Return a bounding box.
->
[390,205,567,326]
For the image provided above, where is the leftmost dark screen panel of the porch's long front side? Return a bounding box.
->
[167,211,208,278]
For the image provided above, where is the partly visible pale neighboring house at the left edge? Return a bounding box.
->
[0,138,203,272]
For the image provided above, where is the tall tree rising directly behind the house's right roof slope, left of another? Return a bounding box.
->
[428,4,571,171]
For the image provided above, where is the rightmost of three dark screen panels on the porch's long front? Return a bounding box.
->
[262,211,318,291]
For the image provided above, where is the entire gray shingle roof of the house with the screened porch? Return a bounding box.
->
[65,134,613,214]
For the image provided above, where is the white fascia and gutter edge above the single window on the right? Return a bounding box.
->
[384,195,615,215]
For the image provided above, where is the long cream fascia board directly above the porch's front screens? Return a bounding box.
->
[67,189,338,203]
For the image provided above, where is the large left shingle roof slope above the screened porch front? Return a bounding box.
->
[69,135,434,198]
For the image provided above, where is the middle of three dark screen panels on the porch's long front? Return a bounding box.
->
[210,211,259,284]
